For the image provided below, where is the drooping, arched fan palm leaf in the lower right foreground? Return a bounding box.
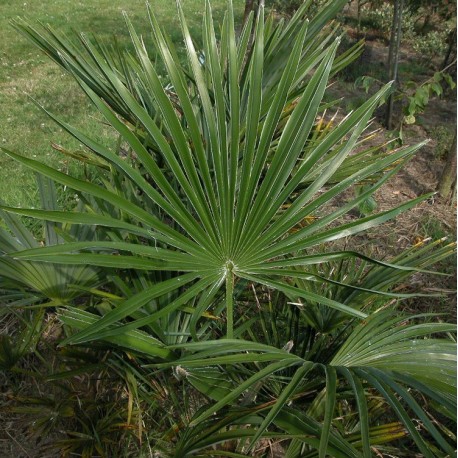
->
[159,310,456,457]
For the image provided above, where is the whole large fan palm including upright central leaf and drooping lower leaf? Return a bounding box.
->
[3,1,454,457]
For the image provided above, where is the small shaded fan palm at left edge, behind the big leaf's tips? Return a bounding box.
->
[0,177,101,376]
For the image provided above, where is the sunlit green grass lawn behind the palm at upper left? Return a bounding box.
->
[0,0,244,206]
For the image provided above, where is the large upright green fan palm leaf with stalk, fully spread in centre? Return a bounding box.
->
[0,3,430,342]
